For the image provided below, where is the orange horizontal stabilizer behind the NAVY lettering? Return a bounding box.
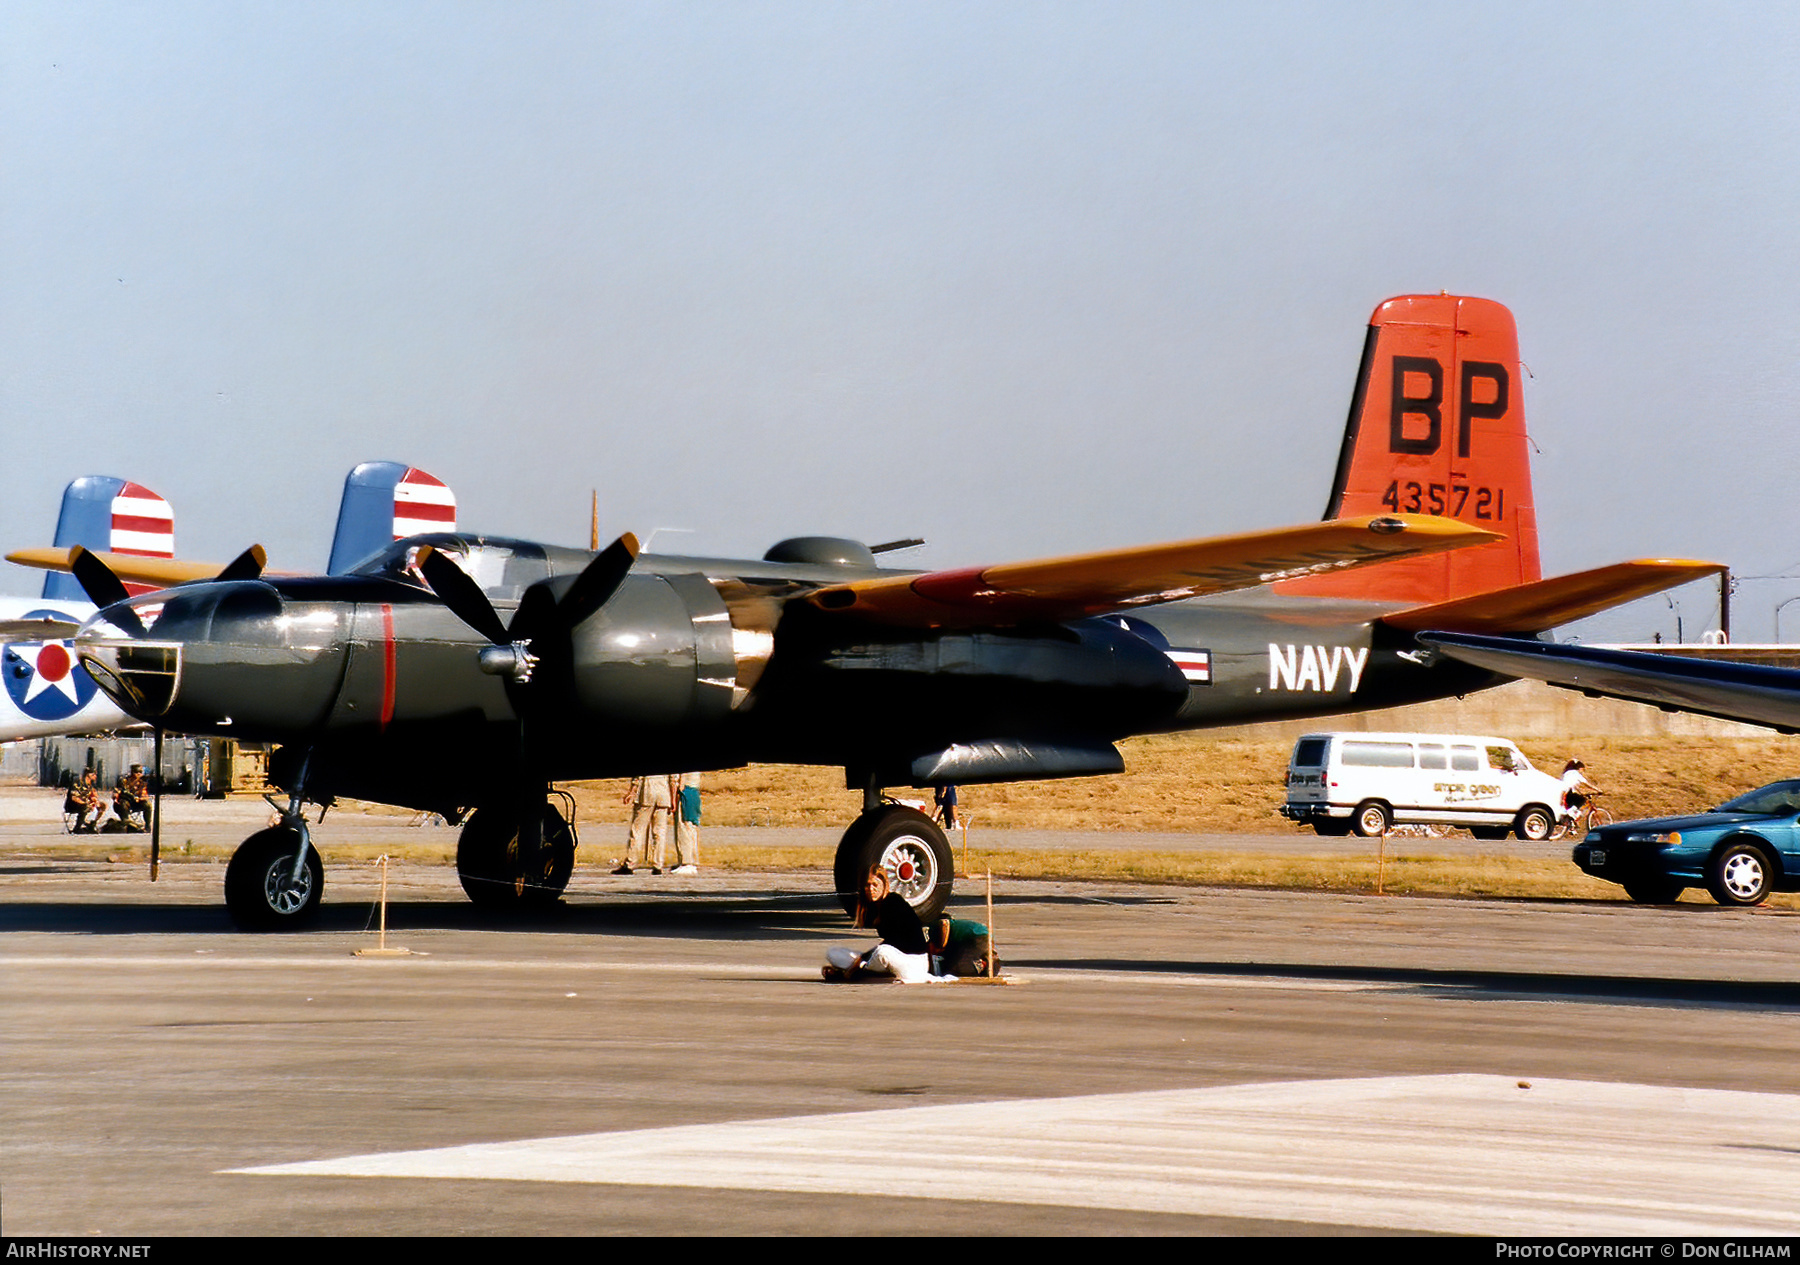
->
[1381,558,1724,633]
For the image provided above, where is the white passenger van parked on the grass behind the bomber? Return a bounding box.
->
[1282,734,1562,839]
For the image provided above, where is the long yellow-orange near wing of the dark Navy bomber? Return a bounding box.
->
[806,515,1499,628]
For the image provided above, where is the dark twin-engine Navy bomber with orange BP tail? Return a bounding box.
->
[21,295,1714,927]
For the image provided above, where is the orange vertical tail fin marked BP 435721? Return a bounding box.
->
[1278,295,1543,603]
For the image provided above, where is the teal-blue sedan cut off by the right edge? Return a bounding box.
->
[1575,777,1800,905]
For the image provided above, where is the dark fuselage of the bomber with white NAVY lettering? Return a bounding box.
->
[77,536,1499,810]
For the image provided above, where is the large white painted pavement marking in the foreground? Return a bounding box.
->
[234,1076,1800,1234]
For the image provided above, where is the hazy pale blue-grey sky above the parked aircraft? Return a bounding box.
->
[0,0,1800,641]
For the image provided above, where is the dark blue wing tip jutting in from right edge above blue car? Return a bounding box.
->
[1418,632,1800,732]
